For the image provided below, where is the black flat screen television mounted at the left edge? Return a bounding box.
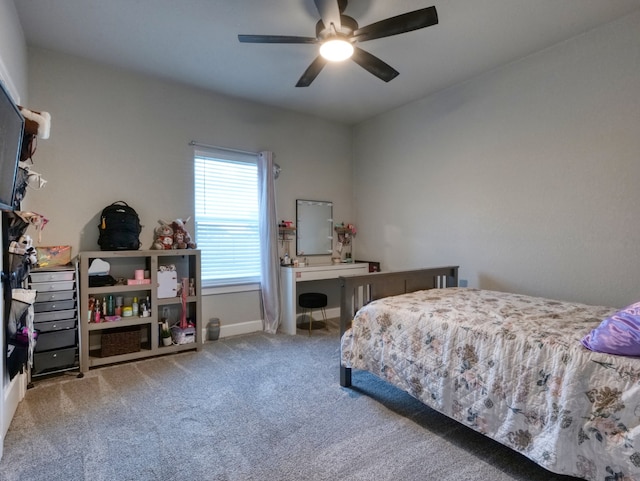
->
[0,81,24,210]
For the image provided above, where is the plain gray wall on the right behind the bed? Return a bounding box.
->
[354,12,640,306]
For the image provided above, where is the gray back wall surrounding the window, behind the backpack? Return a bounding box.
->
[24,49,352,334]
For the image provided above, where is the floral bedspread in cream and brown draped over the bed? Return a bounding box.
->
[341,288,640,481]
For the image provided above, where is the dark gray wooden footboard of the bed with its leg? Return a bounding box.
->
[340,266,458,387]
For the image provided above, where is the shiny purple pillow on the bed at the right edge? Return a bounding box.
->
[582,302,640,356]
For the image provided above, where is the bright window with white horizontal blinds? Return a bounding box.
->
[194,149,260,287]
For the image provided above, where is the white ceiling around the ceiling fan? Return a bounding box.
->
[14,0,640,124]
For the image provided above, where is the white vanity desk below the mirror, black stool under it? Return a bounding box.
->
[280,262,369,335]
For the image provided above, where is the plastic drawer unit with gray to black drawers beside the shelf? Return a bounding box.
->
[28,266,78,377]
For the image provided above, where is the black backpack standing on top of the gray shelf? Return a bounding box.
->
[98,200,142,251]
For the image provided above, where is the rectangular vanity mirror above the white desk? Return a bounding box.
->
[296,199,333,256]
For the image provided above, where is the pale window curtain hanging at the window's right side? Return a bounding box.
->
[258,151,281,334]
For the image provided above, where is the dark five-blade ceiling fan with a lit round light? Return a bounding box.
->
[238,0,438,87]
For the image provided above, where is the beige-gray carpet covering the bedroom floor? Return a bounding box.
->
[0,327,573,481]
